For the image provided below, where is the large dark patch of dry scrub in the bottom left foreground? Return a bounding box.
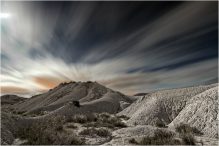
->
[15,117,85,145]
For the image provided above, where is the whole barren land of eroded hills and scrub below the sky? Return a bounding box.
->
[1,82,218,145]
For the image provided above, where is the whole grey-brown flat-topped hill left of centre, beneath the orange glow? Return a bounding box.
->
[14,81,134,114]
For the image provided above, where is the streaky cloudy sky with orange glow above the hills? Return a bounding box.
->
[0,1,218,96]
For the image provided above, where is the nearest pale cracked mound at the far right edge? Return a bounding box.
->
[169,86,218,138]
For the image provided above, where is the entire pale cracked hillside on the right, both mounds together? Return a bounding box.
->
[118,84,218,137]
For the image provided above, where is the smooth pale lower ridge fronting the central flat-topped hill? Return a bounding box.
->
[39,91,131,117]
